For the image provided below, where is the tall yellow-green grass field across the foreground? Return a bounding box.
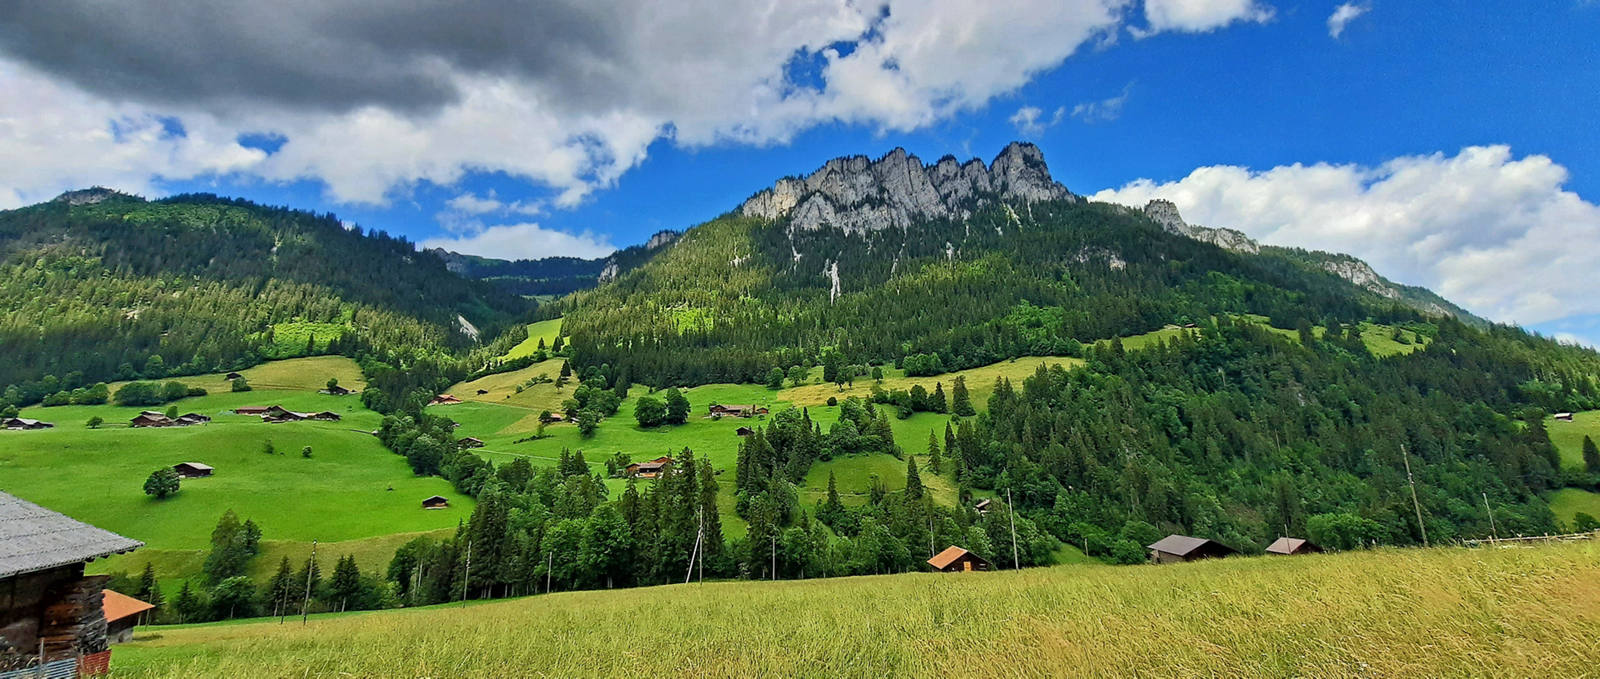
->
[112,541,1600,677]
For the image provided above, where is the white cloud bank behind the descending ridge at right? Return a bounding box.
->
[1093,146,1600,323]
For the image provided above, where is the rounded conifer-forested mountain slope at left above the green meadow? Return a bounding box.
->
[0,189,531,404]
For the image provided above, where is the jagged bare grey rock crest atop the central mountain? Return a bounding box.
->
[739,143,1078,232]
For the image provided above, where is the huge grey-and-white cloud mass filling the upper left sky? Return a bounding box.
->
[0,0,1270,207]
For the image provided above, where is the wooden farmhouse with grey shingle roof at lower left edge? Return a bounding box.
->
[0,493,144,677]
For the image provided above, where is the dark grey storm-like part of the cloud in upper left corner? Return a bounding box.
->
[0,0,629,112]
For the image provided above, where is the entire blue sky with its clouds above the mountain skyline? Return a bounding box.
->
[0,0,1600,343]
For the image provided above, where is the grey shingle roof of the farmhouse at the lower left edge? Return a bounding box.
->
[0,493,144,578]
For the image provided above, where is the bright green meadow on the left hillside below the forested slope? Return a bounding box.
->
[0,357,472,589]
